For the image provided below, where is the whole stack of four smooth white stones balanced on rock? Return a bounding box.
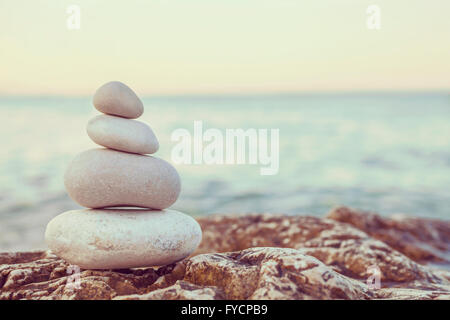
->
[45,82,201,269]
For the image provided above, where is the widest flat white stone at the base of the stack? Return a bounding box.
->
[45,209,202,269]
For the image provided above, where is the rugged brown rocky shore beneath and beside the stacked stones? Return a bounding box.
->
[0,207,450,300]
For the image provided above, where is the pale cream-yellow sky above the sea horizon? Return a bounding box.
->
[0,0,450,95]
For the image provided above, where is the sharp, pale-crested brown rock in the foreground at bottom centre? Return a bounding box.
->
[185,247,371,299]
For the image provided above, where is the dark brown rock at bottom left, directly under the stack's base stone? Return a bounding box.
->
[0,252,176,299]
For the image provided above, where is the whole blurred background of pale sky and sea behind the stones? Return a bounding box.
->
[0,0,450,251]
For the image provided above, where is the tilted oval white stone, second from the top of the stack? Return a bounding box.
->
[86,114,159,154]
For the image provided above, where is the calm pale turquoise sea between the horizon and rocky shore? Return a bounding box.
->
[0,94,450,219]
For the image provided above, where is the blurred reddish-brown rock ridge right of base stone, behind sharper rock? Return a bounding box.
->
[196,214,448,283]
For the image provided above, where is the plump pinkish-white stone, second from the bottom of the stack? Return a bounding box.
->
[64,148,181,209]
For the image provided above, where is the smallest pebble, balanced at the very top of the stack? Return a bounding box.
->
[93,81,144,119]
